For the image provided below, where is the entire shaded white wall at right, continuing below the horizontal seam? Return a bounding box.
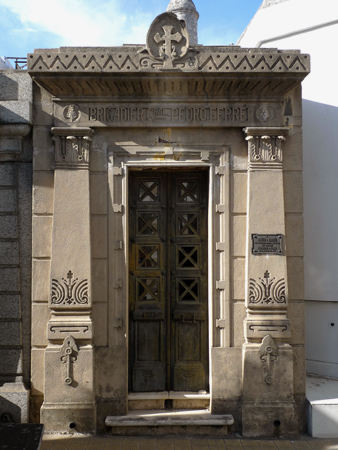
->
[303,100,338,377]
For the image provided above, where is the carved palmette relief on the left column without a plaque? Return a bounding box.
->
[51,270,89,309]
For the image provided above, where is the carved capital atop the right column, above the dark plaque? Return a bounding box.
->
[243,127,288,170]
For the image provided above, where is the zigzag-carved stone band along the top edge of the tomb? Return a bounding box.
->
[28,48,310,74]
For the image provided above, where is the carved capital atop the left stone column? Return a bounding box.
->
[52,127,93,169]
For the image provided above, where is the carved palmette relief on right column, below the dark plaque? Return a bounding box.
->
[249,270,287,308]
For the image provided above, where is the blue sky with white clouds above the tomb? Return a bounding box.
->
[0,0,262,57]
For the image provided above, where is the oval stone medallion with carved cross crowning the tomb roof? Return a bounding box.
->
[145,13,191,70]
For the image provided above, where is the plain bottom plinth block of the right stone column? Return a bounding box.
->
[242,402,298,437]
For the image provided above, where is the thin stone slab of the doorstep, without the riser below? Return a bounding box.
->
[105,410,234,427]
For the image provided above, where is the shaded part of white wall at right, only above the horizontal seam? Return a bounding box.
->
[303,100,338,301]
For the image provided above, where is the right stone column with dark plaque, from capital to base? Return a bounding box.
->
[242,128,297,436]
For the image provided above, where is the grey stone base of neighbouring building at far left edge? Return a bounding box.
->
[0,382,29,423]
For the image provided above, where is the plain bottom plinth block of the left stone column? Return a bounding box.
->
[41,403,96,434]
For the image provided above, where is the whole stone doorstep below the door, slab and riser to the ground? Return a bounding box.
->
[105,410,234,436]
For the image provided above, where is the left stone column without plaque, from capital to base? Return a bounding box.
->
[41,128,96,432]
